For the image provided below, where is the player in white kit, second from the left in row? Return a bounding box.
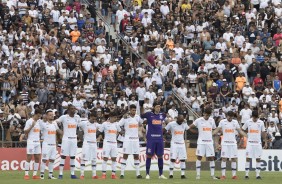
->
[39,109,62,179]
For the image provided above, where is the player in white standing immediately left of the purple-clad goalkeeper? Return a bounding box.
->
[119,105,143,179]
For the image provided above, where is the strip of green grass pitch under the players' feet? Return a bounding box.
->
[0,171,282,184]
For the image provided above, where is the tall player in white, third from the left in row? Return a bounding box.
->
[56,104,80,179]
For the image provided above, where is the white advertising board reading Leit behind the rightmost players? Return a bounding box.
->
[238,150,282,171]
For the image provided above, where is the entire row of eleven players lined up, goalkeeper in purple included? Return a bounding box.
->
[24,103,267,180]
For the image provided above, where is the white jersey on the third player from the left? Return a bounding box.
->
[56,115,80,140]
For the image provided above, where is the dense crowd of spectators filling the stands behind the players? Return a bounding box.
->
[0,0,282,149]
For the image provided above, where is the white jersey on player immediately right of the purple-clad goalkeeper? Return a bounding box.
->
[165,121,189,143]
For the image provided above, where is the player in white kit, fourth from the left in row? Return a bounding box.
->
[78,113,100,179]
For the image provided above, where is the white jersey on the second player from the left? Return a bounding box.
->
[39,121,59,144]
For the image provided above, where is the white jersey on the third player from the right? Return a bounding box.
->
[193,117,216,144]
